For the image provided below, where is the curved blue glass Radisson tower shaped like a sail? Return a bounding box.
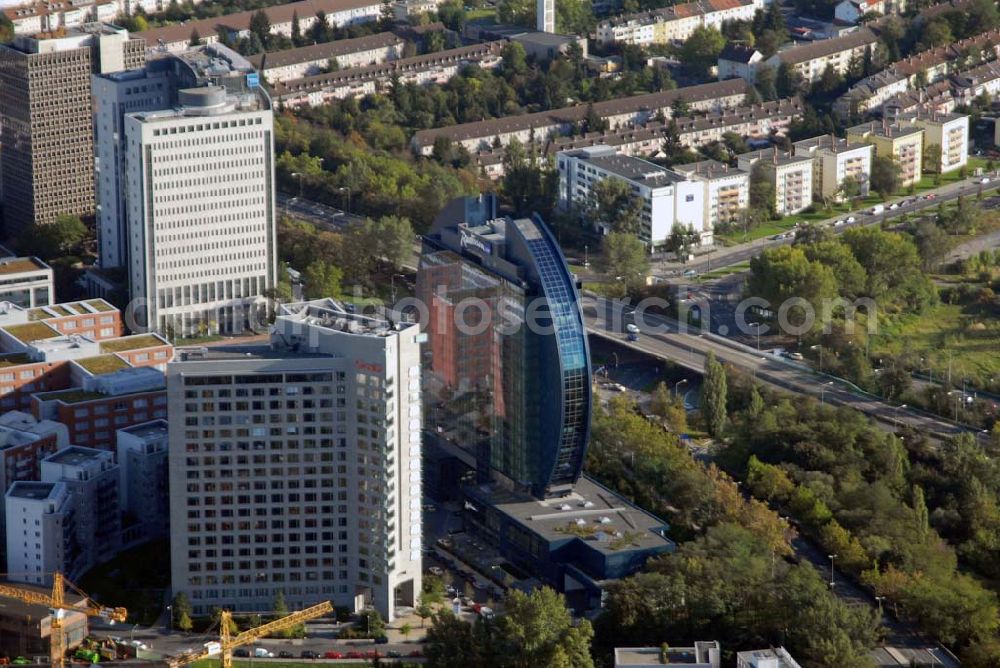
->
[417,195,591,498]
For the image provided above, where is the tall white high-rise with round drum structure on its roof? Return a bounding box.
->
[125,81,277,334]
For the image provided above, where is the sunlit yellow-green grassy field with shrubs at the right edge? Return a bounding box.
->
[872,304,1000,380]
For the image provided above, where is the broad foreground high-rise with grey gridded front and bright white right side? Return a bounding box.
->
[167,300,424,619]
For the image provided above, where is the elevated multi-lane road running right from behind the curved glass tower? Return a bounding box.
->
[584,297,985,444]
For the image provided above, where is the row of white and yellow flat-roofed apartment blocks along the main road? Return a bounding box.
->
[556,112,969,247]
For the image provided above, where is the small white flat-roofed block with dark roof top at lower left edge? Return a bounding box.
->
[6,481,79,585]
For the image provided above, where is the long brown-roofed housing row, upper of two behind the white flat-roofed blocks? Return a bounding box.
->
[411,79,750,155]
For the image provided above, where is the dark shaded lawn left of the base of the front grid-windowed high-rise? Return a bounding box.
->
[76,540,170,626]
